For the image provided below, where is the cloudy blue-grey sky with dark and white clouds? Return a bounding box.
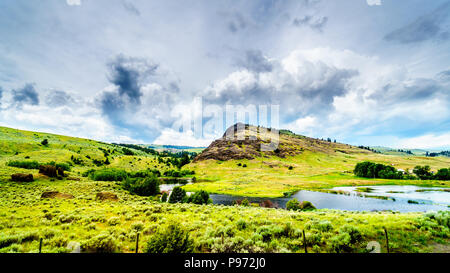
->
[0,0,450,149]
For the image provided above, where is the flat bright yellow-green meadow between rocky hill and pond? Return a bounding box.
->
[184,151,450,197]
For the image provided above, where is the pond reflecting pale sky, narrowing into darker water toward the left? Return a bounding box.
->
[210,186,450,212]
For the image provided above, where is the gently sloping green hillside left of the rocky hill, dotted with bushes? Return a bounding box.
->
[0,127,179,180]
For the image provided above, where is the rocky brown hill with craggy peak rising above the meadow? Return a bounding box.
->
[194,123,372,162]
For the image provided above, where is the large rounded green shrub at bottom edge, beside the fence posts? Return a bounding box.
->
[145,224,193,253]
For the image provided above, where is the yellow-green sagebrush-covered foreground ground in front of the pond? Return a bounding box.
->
[0,180,450,253]
